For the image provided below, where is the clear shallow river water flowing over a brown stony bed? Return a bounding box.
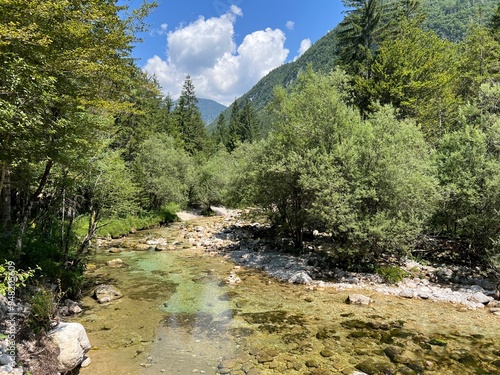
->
[74,219,500,375]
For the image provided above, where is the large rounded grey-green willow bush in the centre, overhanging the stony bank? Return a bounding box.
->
[249,71,436,259]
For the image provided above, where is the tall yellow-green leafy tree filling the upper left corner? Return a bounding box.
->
[0,0,155,256]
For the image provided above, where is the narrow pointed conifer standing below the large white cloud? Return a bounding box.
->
[173,75,208,154]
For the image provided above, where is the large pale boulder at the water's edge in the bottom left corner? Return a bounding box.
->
[48,323,91,373]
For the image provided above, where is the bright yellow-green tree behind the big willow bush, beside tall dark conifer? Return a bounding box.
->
[356,23,458,139]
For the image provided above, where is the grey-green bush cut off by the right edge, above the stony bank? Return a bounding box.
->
[434,107,500,262]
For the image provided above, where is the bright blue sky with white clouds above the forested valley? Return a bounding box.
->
[127,0,343,105]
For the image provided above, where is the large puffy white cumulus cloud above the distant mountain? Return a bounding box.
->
[143,5,289,105]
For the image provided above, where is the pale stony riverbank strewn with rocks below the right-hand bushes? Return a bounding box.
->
[171,209,500,316]
